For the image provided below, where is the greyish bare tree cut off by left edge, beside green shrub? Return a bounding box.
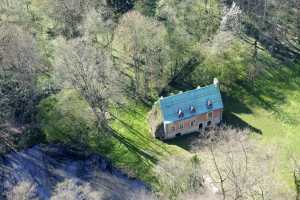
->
[0,24,39,121]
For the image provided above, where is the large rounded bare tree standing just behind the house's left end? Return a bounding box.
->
[113,11,169,99]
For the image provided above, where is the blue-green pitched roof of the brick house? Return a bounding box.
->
[159,84,223,123]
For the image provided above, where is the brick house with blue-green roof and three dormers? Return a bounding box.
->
[151,78,223,139]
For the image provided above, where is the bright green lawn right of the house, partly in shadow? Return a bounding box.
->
[225,59,300,186]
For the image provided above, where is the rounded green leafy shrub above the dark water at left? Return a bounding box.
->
[39,90,95,145]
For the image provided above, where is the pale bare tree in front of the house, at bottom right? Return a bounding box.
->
[193,128,292,200]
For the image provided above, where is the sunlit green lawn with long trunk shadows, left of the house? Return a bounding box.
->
[109,103,190,186]
